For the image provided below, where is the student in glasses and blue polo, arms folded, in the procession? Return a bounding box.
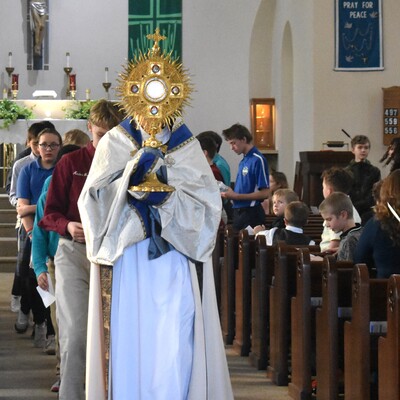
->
[16,128,62,348]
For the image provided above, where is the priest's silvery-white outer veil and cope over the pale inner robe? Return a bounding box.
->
[78,122,233,400]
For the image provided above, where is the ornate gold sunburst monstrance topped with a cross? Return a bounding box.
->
[117,28,192,192]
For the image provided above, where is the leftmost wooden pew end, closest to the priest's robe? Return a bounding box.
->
[221,225,238,344]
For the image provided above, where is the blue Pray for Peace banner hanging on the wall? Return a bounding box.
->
[335,0,383,71]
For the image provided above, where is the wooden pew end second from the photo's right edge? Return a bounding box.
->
[344,264,393,400]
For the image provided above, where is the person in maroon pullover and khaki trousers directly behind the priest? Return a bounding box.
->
[39,100,122,400]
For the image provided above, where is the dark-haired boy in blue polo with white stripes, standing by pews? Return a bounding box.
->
[221,124,269,231]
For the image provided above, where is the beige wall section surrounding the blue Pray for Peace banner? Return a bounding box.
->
[313,0,400,174]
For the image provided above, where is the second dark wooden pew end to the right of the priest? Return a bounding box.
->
[233,229,255,356]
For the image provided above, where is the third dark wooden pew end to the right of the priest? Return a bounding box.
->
[250,236,277,369]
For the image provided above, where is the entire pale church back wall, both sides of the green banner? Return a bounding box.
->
[0,0,400,181]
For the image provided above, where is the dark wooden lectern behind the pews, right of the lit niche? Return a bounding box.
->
[294,150,354,207]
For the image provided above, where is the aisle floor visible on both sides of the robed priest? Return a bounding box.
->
[0,272,290,400]
